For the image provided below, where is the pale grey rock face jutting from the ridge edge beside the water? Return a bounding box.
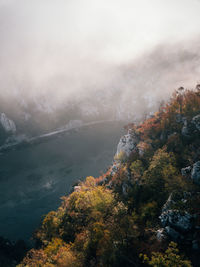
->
[116,131,139,157]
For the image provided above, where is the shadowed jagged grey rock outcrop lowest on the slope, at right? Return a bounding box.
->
[156,192,200,251]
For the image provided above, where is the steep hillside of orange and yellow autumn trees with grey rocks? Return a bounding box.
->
[18,86,200,267]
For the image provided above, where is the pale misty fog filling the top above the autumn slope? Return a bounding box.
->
[0,0,200,120]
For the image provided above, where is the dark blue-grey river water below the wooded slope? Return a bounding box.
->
[0,122,124,244]
